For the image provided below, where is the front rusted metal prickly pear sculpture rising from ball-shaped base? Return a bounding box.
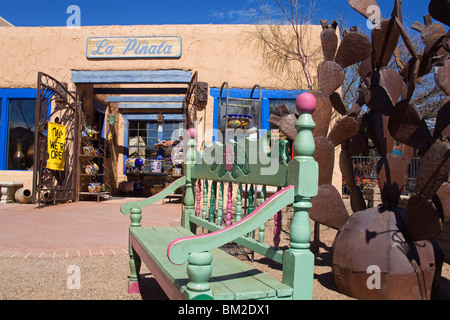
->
[333,1,450,299]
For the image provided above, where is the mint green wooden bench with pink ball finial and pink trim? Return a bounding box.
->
[121,93,318,300]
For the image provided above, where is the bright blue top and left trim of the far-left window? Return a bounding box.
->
[0,88,37,171]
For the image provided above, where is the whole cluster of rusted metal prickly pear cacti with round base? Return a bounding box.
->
[268,0,450,299]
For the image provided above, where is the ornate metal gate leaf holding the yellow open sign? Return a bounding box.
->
[33,72,79,206]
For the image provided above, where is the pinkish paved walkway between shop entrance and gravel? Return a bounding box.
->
[0,198,181,259]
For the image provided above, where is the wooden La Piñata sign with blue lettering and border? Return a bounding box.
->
[86,36,181,59]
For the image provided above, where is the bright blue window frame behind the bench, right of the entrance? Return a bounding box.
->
[210,88,304,142]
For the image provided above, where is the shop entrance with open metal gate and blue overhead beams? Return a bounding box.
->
[33,70,208,204]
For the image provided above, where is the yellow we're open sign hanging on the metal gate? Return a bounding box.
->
[47,122,67,171]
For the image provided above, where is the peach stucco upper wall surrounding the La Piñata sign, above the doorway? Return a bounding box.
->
[0,25,321,89]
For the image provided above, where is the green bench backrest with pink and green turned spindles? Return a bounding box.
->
[182,94,318,263]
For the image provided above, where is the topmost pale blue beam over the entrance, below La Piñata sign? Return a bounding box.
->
[72,70,192,83]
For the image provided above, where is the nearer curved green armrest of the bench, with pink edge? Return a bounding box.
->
[167,186,294,265]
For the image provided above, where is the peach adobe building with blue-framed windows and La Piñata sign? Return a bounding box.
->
[0,25,342,199]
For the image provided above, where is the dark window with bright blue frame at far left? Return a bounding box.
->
[0,89,36,170]
